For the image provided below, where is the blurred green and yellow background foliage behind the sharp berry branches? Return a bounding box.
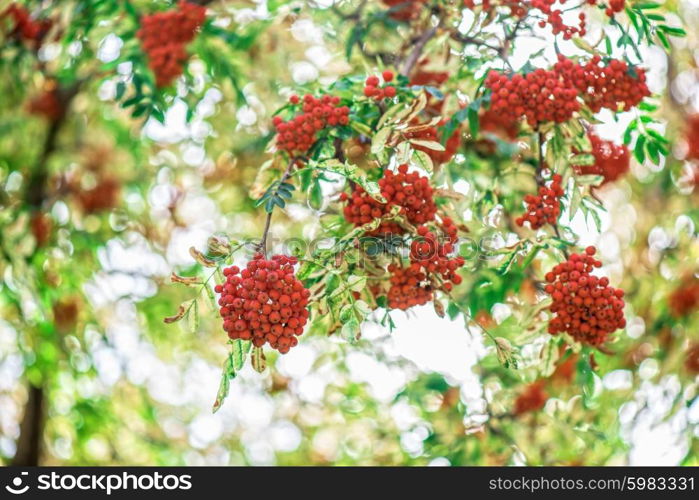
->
[0,0,699,465]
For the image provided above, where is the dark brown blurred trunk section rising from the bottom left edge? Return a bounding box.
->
[11,384,46,467]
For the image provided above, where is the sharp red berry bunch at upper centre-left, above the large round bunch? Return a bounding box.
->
[272,94,350,155]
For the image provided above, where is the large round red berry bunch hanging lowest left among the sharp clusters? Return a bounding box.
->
[216,254,310,354]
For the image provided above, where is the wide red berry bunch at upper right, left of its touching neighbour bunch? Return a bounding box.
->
[485,69,580,127]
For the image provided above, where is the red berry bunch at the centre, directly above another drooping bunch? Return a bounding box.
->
[340,165,437,234]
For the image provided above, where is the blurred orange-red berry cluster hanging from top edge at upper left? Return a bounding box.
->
[136,0,206,87]
